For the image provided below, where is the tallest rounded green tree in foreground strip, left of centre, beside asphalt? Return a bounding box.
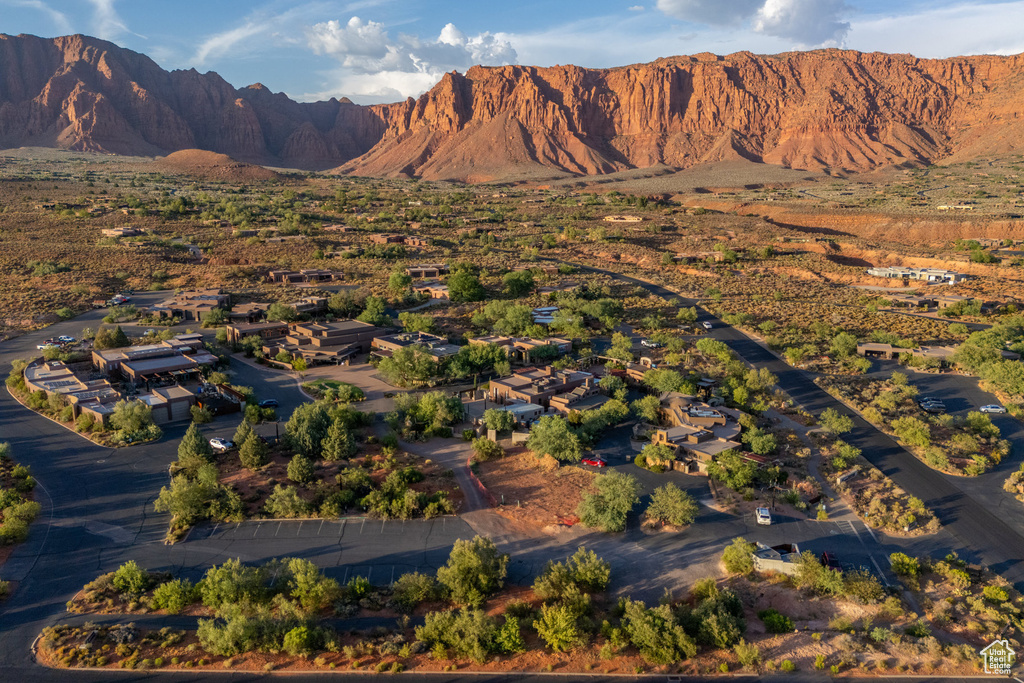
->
[437,536,509,606]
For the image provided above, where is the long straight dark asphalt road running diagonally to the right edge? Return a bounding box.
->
[580,266,1024,590]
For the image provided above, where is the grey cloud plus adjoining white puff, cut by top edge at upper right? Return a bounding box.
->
[657,0,851,47]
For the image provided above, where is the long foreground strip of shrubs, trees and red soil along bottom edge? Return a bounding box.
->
[37,537,999,677]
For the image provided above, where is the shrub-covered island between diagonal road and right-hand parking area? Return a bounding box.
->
[815,372,1011,476]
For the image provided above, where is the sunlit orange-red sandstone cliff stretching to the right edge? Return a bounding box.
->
[339,50,1024,179]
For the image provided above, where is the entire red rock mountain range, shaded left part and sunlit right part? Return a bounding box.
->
[0,36,1024,180]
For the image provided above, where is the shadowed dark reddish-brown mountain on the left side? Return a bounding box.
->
[0,35,383,169]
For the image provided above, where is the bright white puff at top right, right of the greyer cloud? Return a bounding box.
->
[754,0,850,46]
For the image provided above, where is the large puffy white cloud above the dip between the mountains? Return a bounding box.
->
[306,16,517,100]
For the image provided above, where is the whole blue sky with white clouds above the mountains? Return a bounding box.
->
[0,0,1024,103]
